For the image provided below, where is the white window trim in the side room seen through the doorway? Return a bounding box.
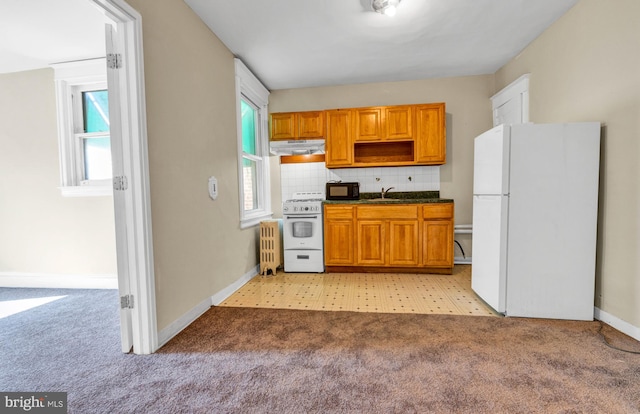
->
[51,58,113,197]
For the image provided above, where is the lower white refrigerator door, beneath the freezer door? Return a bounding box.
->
[471,195,509,313]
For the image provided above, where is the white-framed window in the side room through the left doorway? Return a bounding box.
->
[52,59,112,196]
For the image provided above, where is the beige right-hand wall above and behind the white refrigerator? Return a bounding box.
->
[495,0,640,327]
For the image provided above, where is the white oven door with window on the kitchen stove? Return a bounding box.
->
[283,214,323,250]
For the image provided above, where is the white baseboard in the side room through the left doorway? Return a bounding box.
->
[0,272,118,289]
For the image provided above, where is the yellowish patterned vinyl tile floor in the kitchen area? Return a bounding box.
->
[219,265,497,316]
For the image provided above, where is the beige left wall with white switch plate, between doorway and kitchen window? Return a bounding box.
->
[128,0,258,330]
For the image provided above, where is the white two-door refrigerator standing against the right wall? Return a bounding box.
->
[471,122,600,320]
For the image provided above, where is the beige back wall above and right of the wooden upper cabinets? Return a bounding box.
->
[269,75,494,255]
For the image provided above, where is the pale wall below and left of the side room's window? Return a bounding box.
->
[0,69,117,275]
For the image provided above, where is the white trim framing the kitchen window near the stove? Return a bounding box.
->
[235,59,273,229]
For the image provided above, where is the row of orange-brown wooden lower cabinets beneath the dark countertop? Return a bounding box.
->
[324,203,453,274]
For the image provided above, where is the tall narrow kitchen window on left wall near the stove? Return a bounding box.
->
[235,59,273,228]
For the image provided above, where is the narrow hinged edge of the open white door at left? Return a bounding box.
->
[105,24,133,352]
